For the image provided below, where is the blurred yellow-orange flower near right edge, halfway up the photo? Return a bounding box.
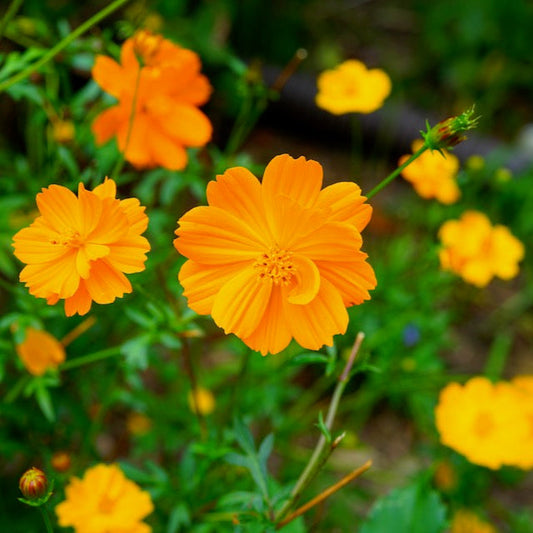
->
[439,211,525,287]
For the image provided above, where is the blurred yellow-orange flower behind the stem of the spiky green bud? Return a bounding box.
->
[398,139,461,204]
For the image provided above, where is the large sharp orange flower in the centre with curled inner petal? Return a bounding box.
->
[174,154,376,355]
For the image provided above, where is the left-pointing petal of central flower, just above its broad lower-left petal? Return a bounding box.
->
[179,261,249,315]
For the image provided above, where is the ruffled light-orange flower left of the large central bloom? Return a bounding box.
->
[13,179,150,316]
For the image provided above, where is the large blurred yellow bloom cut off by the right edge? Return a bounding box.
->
[435,376,533,469]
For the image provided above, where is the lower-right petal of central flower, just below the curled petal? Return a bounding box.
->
[284,278,348,350]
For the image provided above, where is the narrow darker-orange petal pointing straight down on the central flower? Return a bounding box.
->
[242,287,292,355]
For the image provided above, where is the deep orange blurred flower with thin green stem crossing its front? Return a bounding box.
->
[92,30,212,170]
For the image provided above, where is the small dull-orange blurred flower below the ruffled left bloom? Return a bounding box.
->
[16,327,65,376]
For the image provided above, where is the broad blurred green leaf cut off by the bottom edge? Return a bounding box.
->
[359,483,446,533]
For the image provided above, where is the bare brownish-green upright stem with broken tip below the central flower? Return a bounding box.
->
[276,332,365,523]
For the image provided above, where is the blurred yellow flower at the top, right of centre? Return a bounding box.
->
[316,59,392,115]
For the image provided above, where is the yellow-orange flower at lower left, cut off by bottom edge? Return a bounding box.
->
[55,464,154,533]
